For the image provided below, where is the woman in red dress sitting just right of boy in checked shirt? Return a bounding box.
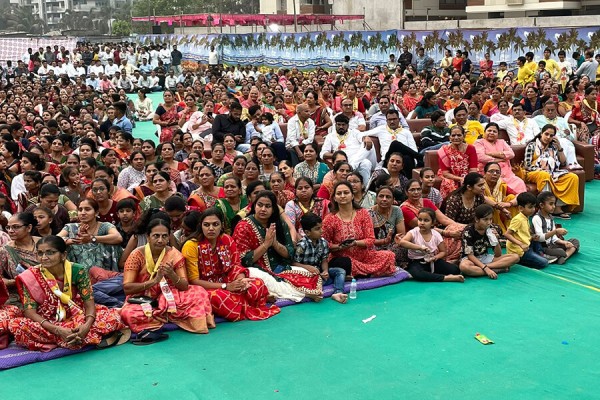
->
[323,181,396,277]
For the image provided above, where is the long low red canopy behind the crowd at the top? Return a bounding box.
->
[131,14,365,26]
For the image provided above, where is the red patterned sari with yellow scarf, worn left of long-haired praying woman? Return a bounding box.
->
[182,235,280,321]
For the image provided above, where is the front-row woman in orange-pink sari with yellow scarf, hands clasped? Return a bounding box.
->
[121,219,215,344]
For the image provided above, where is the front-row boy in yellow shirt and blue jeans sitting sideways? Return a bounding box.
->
[504,192,556,269]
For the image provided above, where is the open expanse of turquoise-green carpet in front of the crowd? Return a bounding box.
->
[0,267,600,400]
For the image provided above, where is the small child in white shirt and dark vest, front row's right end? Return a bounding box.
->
[531,192,579,264]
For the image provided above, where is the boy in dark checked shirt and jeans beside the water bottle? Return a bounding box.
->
[292,213,348,304]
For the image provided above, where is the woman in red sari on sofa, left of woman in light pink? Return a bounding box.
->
[438,125,478,199]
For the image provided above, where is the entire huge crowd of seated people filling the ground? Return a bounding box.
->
[0,43,600,351]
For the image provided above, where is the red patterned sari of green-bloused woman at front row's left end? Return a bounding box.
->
[8,264,125,351]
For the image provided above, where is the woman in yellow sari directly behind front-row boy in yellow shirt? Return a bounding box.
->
[483,161,519,233]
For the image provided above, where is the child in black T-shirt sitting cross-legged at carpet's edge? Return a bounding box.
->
[459,204,519,279]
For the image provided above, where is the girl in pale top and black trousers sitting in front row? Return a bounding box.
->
[396,207,465,282]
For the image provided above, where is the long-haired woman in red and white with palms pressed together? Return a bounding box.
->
[233,190,323,302]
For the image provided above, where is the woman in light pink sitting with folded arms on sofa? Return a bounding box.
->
[475,122,527,193]
